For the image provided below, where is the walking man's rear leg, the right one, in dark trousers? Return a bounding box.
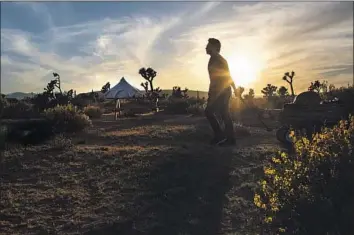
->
[220,90,235,145]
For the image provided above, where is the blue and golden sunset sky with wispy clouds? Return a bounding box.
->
[1,2,353,94]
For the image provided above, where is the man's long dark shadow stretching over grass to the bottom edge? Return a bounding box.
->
[87,146,235,235]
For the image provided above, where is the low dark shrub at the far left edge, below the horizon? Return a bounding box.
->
[2,101,39,119]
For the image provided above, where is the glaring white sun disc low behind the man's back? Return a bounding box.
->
[228,55,263,87]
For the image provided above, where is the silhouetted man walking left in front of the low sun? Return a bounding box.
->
[205,38,236,145]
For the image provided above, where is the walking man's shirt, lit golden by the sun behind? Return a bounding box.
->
[208,55,232,96]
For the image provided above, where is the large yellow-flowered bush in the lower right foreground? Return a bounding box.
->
[254,117,354,235]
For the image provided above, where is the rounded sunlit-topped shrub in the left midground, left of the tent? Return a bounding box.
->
[43,104,92,133]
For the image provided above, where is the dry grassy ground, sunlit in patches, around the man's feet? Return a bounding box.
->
[0,113,282,235]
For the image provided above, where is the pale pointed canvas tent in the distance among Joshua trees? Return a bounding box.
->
[104,77,143,119]
